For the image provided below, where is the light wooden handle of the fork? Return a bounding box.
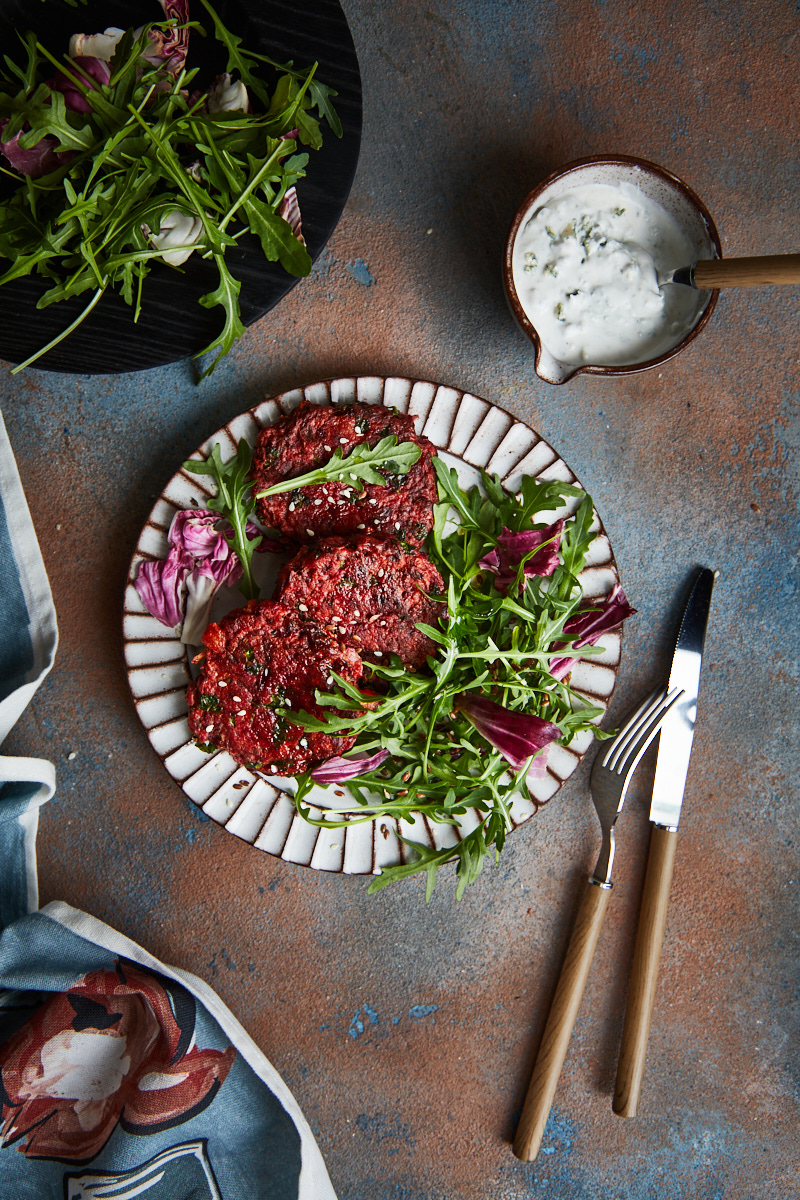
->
[513,880,612,1163]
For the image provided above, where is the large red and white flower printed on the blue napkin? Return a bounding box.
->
[0,962,236,1162]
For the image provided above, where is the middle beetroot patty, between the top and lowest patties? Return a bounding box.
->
[275,534,445,667]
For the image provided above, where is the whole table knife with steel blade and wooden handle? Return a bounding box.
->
[613,568,716,1117]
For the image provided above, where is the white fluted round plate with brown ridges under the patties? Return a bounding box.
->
[122,376,621,875]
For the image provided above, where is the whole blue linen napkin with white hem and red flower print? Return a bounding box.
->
[0,415,336,1200]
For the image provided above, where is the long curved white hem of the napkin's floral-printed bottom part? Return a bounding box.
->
[40,900,337,1200]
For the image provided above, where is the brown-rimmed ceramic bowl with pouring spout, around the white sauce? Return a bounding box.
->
[503,155,722,383]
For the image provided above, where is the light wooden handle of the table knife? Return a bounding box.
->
[614,826,678,1117]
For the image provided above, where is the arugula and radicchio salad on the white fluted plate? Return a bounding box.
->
[165,443,633,895]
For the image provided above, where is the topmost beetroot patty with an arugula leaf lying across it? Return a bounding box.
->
[251,401,438,546]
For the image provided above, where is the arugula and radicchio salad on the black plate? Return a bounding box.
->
[0,0,342,374]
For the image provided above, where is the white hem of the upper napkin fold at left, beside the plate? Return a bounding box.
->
[0,412,59,743]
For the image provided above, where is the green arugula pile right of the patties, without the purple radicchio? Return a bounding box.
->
[287,458,633,899]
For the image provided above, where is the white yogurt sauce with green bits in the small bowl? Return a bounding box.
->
[512,184,708,366]
